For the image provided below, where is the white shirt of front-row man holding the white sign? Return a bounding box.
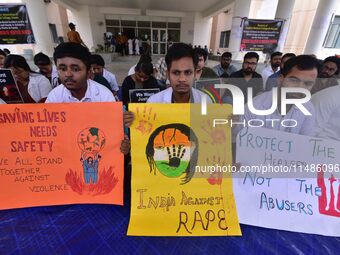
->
[233,91,315,138]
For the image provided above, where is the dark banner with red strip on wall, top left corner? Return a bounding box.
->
[0,4,35,44]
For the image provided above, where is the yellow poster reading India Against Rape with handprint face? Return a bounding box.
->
[128,104,241,236]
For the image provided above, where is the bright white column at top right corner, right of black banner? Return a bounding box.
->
[304,0,340,55]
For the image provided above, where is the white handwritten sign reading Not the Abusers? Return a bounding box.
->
[233,128,340,236]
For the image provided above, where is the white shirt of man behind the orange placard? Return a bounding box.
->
[46,80,116,103]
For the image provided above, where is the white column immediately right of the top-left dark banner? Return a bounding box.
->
[23,0,55,57]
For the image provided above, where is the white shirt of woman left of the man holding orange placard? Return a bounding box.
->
[27,73,52,102]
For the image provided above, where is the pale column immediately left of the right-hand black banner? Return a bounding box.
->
[229,0,251,59]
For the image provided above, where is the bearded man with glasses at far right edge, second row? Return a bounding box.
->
[312,57,340,94]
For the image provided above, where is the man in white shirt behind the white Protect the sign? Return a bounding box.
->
[233,55,319,137]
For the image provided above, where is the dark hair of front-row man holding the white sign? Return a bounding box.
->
[281,55,320,76]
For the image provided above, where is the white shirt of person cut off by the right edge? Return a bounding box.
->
[312,86,340,141]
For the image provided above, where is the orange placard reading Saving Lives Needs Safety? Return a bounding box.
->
[0,103,124,209]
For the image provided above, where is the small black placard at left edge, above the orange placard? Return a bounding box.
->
[0,68,24,104]
